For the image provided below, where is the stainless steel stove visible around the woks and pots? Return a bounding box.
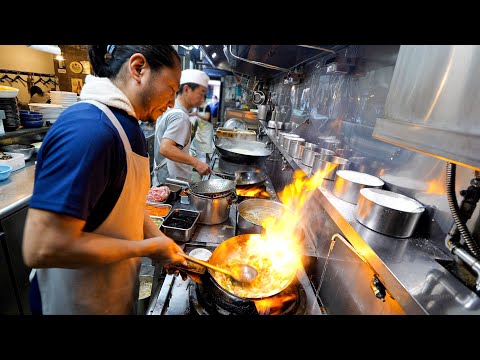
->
[146,153,322,316]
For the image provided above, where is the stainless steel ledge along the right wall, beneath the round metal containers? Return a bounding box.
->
[262,122,480,314]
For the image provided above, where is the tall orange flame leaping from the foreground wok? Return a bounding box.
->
[215,164,337,300]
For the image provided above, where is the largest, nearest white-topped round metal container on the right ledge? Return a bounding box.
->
[355,188,425,238]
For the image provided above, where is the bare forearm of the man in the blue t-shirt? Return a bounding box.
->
[22,208,184,269]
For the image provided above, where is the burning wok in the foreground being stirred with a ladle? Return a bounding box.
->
[208,234,297,300]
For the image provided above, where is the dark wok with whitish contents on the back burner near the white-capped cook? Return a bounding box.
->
[215,137,273,164]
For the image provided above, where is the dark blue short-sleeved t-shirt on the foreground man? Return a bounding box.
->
[30,103,148,232]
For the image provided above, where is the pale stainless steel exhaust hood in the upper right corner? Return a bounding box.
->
[372,45,480,170]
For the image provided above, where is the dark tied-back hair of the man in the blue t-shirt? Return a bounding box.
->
[88,44,180,80]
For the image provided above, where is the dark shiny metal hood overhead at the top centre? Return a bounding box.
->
[200,45,346,80]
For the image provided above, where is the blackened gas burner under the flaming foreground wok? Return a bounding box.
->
[189,279,307,315]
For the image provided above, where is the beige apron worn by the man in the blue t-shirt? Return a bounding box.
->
[37,100,150,315]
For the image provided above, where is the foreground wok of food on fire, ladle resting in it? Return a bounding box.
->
[208,234,296,300]
